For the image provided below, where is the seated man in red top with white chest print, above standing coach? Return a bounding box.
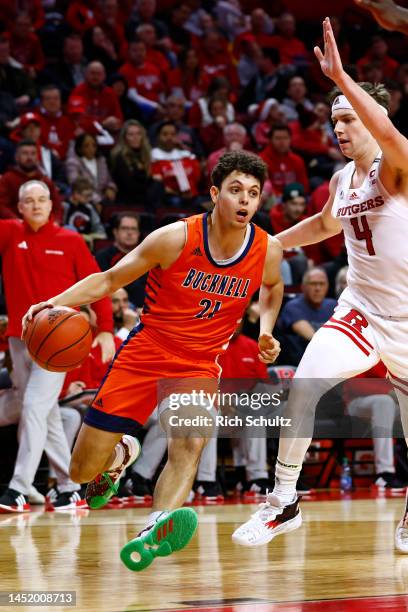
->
[39,85,75,160]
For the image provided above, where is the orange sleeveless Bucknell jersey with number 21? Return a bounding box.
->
[142,213,268,361]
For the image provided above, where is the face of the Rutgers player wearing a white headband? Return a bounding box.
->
[332,109,373,159]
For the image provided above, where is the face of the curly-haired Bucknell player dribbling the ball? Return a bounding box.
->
[210,170,261,227]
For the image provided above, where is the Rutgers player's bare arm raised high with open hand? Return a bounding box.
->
[314,17,408,180]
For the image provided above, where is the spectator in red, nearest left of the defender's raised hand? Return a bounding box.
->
[270,13,310,68]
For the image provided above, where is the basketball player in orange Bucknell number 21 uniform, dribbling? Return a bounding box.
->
[24,151,283,571]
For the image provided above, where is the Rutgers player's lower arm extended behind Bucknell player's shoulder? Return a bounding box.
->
[275,172,341,249]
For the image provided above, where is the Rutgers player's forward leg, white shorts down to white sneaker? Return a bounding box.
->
[232,307,379,546]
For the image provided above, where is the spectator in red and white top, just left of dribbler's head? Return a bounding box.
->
[152,121,201,207]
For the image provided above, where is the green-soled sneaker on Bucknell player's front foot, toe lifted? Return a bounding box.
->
[120,508,198,572]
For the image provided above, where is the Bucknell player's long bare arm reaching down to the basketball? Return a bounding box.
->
[23,221,186,333]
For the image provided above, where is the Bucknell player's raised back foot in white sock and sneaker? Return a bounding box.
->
[85,435,142,510]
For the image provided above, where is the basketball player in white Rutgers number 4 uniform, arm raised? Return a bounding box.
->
[233,18,408,553]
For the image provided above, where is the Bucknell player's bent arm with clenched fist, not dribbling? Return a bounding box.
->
[258,236,283,363]
